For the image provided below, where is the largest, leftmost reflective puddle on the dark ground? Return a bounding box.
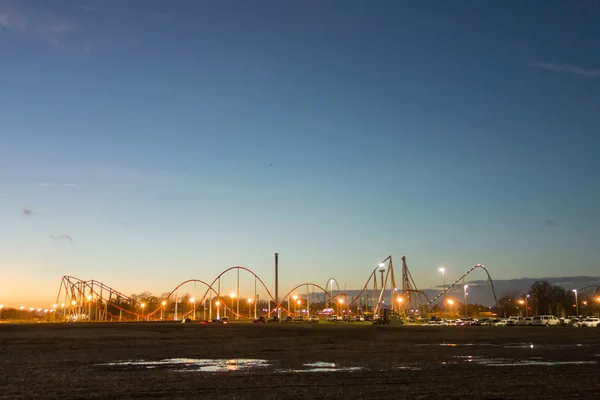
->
[99,358,270,372]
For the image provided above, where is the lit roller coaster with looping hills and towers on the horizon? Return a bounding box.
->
[56,253,497,321]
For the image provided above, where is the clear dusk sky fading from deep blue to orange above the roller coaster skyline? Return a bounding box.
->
[0,0,600,306]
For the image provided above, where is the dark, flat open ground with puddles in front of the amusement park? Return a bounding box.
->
[0,323,600,399]
